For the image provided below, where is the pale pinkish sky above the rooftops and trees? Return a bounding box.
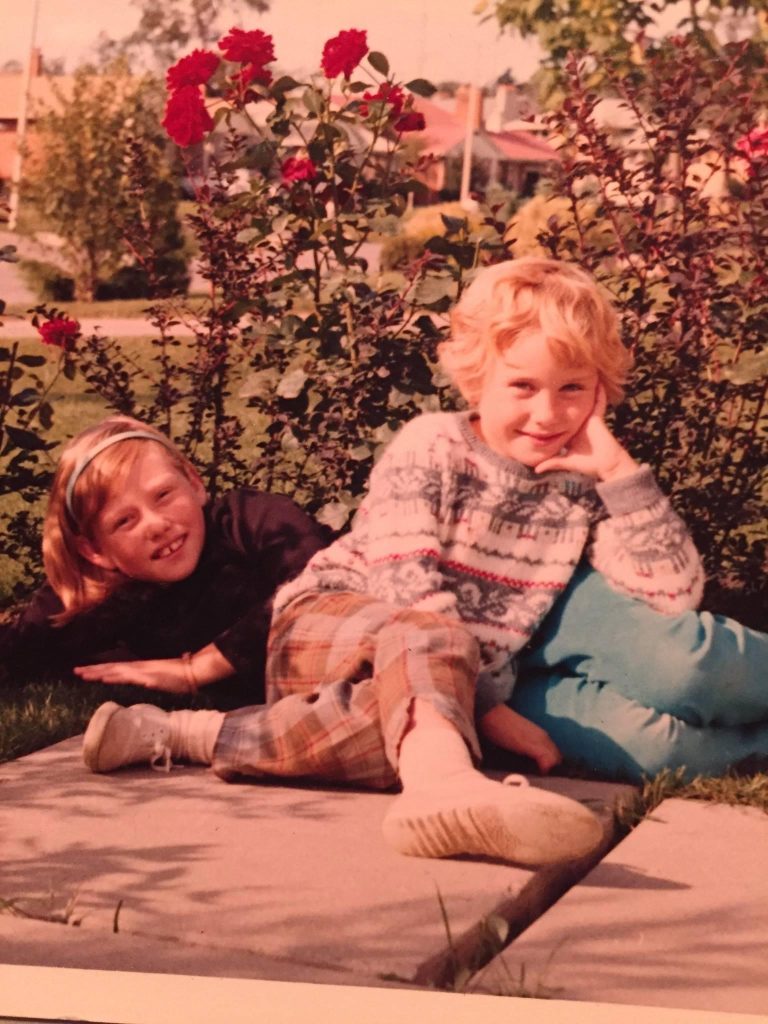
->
[0,0,540,85]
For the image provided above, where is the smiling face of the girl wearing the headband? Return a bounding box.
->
[81,442,206,584]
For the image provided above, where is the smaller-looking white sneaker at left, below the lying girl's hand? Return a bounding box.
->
[83,700,171,772]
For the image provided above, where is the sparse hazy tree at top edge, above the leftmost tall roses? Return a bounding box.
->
[100,0,269,67]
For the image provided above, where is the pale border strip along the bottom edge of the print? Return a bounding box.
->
[0,965,755,1024]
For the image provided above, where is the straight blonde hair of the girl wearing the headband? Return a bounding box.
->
[43,416,197,625]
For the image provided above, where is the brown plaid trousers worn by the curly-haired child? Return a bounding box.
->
[213,591,479,788]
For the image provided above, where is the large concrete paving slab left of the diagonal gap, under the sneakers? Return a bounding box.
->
[0,737,628,985]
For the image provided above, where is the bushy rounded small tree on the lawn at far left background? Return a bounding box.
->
[23,63,186,300]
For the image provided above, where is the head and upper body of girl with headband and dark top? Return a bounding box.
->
[0,416,324,707]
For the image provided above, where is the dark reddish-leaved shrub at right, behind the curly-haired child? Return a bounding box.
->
[536,38,768,626]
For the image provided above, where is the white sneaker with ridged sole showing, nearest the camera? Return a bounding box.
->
[382,772,603,866]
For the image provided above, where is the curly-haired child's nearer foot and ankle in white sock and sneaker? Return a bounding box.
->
[382,725,603,864]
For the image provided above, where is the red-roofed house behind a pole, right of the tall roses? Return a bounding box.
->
[414,85,559,201]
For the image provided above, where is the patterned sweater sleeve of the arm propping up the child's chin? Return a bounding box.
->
[590,466,705,614]
